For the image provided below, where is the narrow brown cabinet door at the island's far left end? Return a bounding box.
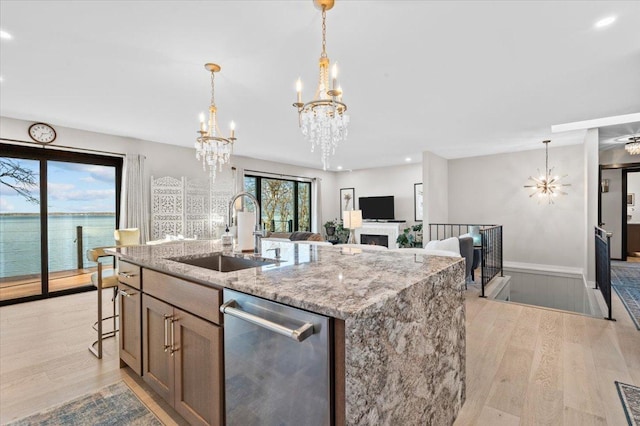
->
[118,283,142,375]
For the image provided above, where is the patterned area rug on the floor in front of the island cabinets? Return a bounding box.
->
[7,382,162,426]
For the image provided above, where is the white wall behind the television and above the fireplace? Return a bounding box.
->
[332,164,422,224]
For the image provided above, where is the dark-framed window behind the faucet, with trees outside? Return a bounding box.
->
[244,176,311,232]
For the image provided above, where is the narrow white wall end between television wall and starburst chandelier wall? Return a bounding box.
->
[422,151,448,223]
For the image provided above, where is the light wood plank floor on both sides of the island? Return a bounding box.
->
[0,286,640,426]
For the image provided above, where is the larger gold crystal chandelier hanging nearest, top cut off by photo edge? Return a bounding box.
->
[293,0,349,170]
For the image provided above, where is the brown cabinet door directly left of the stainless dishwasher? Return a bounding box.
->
[173,309,223,425]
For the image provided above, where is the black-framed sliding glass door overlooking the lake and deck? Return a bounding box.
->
[0,144,122,304]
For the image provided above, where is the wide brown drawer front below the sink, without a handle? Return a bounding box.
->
[144,269,222,324]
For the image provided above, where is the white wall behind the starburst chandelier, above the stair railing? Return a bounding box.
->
[448,144,584,268]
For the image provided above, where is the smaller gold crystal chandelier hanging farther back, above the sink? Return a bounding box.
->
[195,64,236,183]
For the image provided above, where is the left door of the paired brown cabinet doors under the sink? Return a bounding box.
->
[142,294,173,401]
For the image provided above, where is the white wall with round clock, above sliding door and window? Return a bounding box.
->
[0,117,338,230]
